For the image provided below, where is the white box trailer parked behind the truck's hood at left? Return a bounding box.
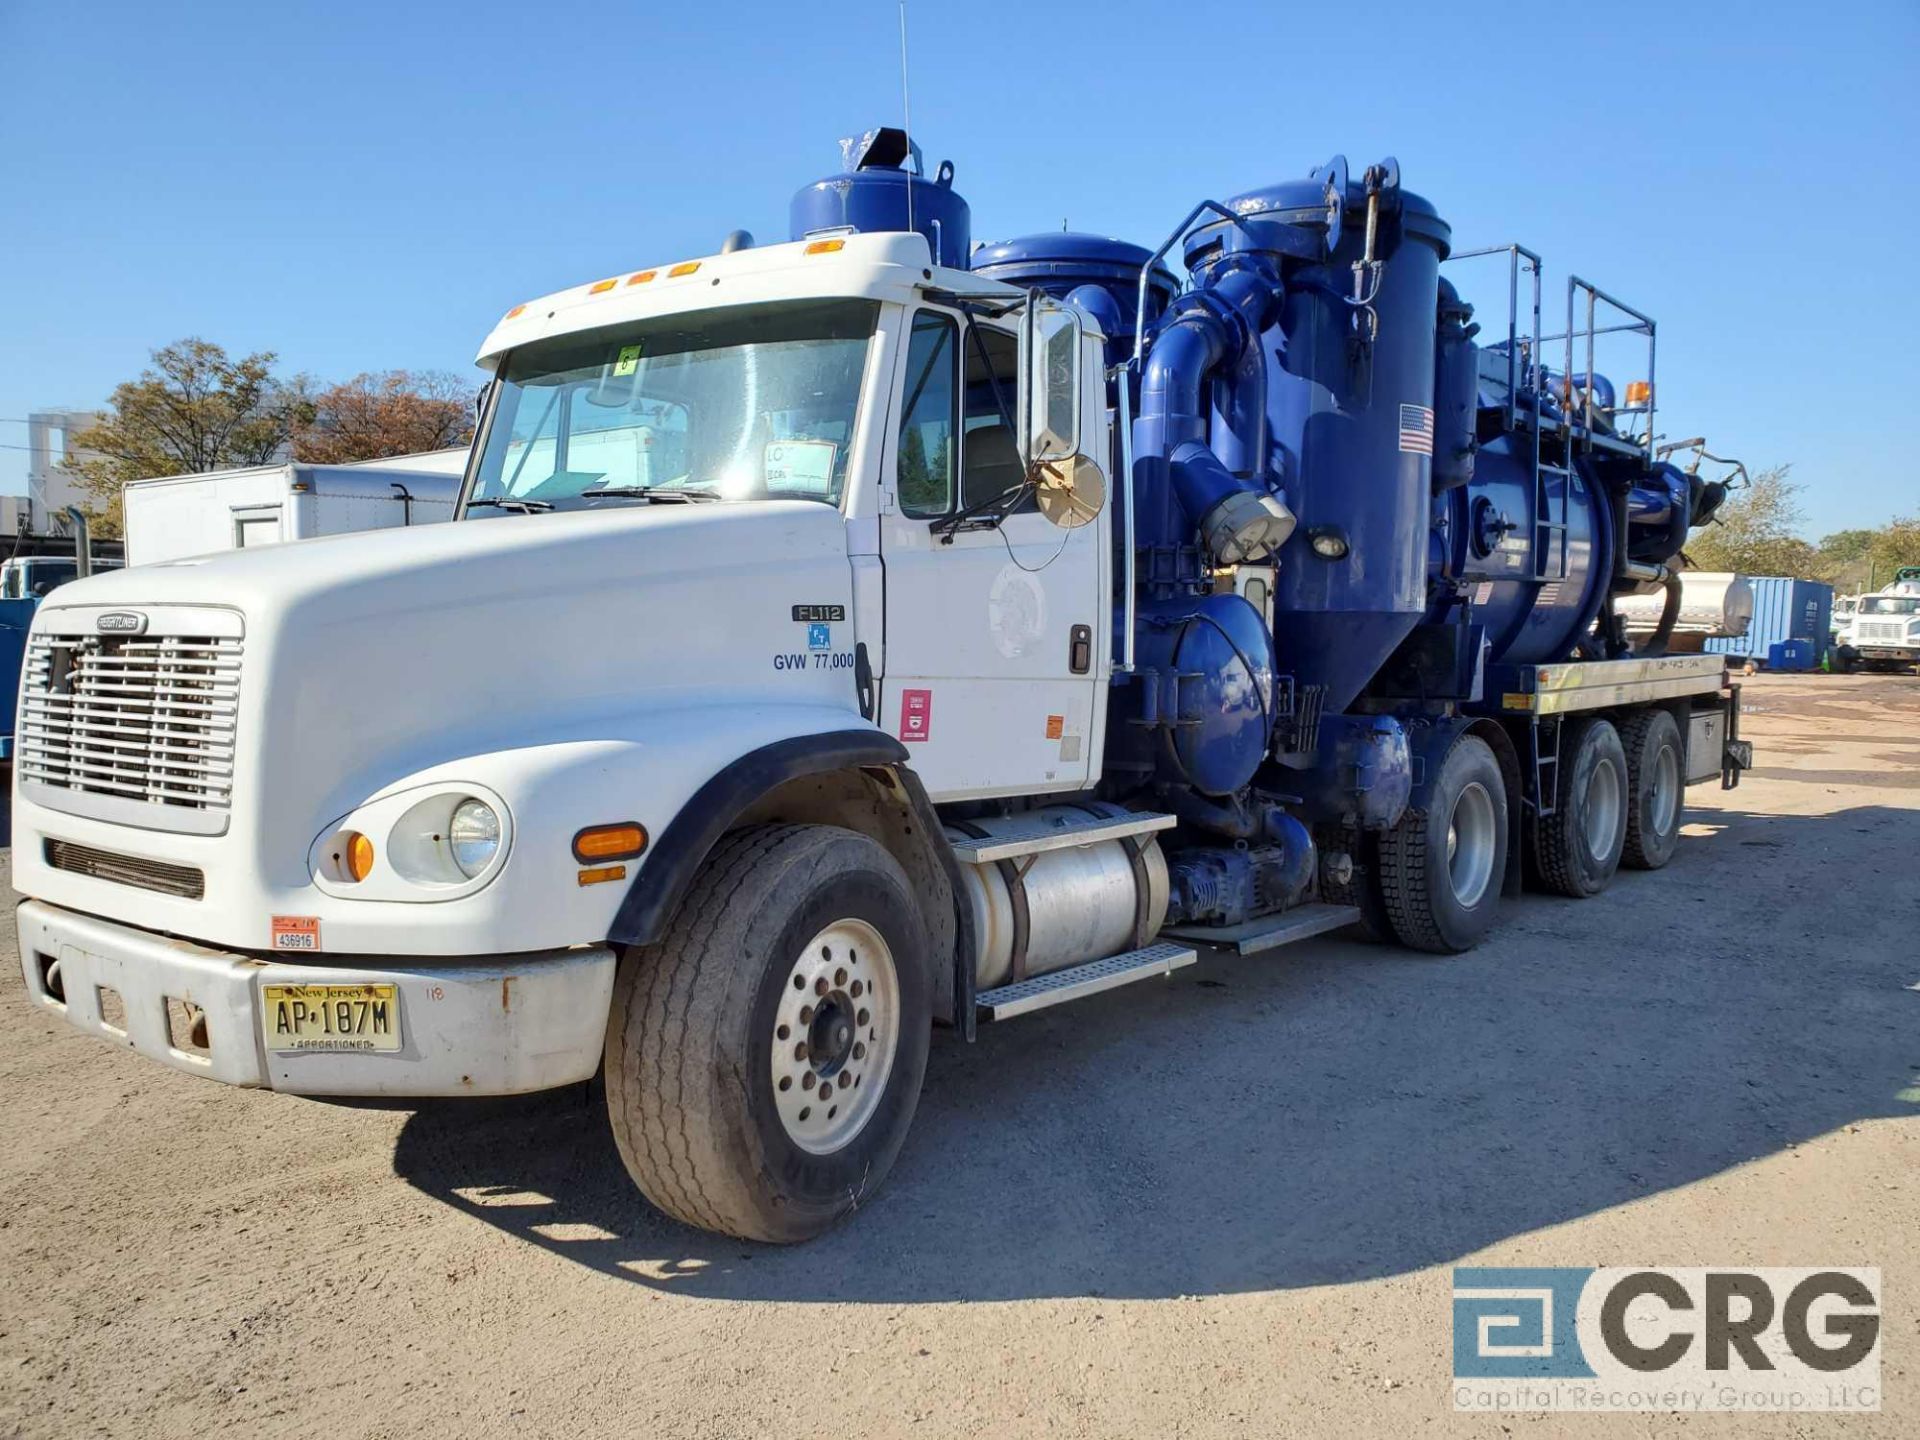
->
[125,449,467,564]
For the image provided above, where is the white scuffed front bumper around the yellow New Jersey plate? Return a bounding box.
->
[19,900,614,1096]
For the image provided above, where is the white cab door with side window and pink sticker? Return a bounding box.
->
[876,307,1110,801]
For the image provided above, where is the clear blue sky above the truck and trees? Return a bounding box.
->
[0,0,1920,536]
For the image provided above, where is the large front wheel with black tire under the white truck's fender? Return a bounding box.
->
[607,826,931,1244]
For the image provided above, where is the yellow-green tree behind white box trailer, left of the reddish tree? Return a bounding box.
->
[69,338,307,536]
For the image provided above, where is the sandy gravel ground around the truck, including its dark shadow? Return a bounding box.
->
[0,676,1920,1436]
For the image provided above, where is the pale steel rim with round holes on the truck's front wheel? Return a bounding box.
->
[770,920,900,1156]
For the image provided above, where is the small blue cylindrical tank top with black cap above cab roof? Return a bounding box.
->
[789,125,973,271]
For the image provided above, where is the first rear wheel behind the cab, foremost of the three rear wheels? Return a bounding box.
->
[1380,735,1507,954]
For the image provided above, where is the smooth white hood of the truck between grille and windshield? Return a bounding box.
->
[26,501,856,887]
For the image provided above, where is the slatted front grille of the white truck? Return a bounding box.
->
[17,634,240,829]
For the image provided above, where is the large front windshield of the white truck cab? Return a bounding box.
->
[468,300,879,515]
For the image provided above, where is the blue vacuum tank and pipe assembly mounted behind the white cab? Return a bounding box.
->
[775,129,1743,950]
